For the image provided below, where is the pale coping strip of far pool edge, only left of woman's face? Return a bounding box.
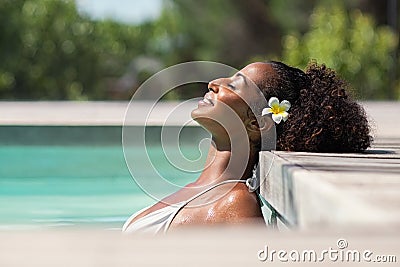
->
[0,101,198,126]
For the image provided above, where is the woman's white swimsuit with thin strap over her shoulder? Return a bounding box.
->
[122,180,246,234]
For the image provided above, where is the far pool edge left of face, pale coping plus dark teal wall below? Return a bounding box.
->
[0,101,209,145]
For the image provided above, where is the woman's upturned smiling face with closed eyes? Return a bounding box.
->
[191,63,276,138]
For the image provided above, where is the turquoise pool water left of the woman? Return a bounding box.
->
[0,145,199,229]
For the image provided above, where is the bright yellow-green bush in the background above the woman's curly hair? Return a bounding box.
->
[283,1,398,99]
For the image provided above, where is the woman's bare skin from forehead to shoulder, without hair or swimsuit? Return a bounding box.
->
[126,63,276,229]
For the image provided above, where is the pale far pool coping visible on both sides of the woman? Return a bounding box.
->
[0,101,400,138]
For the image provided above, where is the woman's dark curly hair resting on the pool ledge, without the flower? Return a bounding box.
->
[262,61,372,152]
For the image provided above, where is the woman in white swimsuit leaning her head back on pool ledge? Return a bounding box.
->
[123,62,372,233]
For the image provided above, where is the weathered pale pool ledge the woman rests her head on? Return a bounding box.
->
[260,140,400,231]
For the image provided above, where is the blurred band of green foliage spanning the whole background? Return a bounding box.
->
[0,0,400,100]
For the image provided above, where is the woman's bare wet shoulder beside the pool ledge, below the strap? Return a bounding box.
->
[214,184,262,221]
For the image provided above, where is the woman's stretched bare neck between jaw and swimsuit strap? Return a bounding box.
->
[195,137,258,185]
